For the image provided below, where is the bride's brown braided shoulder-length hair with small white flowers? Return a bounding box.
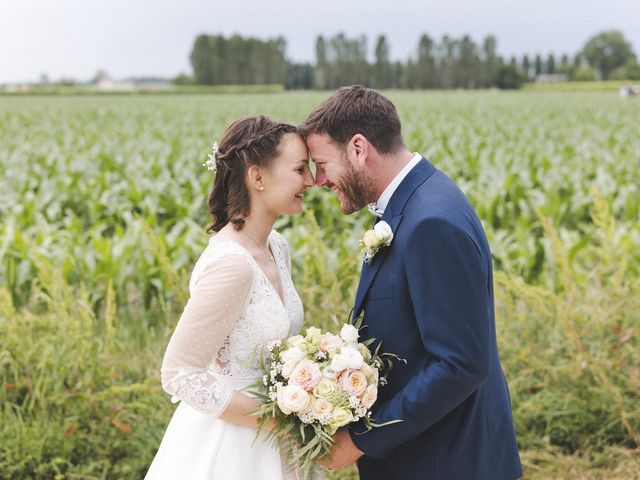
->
[207,115,297,233]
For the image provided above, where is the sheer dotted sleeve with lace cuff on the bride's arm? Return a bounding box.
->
[161,254,253,416]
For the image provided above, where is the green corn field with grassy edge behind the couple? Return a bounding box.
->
[0,92,640,479]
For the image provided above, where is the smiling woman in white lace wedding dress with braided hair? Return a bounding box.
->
[145,116,315,480]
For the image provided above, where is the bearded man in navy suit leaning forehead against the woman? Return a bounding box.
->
[301,86,522,480]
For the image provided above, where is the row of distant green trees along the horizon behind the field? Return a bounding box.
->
[181,31,640,89]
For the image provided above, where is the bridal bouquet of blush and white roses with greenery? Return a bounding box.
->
[254,320,398,478]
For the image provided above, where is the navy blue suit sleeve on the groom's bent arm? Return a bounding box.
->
[350,218,491,459]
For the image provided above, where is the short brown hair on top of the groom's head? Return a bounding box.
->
[299,85,404,153]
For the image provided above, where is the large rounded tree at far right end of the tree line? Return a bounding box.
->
[582,30,636,80]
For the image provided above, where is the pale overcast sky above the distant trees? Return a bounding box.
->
[0,0,640,83]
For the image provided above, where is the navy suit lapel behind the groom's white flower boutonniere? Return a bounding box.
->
[352,158,435,318]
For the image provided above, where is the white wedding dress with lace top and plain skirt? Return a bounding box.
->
[145,231,303,480]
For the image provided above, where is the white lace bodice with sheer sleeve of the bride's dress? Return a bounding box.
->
[161,231,303,415]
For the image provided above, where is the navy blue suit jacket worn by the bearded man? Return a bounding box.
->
[350,158,521,480]
